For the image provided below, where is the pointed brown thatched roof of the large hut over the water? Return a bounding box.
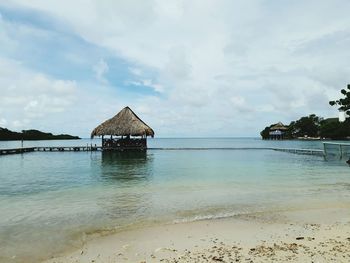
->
[91,107,154,138]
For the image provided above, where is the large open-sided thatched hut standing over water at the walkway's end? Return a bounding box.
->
[91,107,154,150]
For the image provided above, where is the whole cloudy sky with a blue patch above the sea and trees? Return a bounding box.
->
[0,0,350,137]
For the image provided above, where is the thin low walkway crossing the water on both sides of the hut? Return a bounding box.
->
[0,146,324,156]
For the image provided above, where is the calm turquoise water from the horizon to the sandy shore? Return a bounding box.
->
[0,138,350,262]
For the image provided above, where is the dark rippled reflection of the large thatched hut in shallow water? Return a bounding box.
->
[98,151,153,225]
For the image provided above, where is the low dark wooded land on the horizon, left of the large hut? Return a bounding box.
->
[0,127,80,141]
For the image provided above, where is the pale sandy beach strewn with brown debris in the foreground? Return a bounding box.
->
[45,207,350,263]
